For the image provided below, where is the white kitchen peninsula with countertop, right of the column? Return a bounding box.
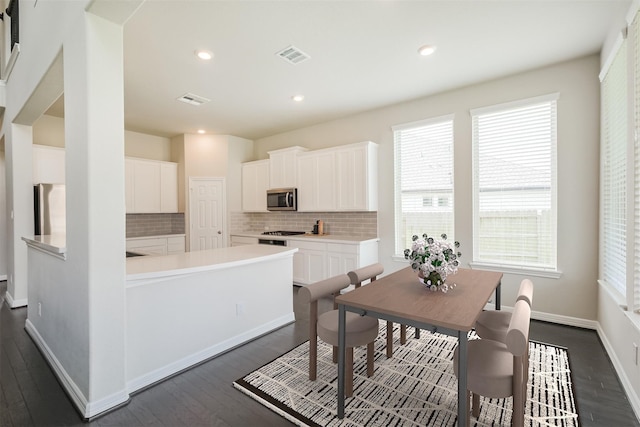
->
[126,245,297,393]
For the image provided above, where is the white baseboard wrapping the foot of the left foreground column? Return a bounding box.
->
[25,319,129,419]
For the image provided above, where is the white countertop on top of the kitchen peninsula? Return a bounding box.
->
[127,245,298,281]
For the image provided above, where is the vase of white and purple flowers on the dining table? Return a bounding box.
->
[404,234,462,292]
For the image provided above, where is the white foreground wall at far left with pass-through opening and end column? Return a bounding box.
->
[3,0,138,417]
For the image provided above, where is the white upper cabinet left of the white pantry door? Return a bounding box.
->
[125,158,178,213]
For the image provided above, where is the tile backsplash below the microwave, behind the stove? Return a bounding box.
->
[229,212,378,237]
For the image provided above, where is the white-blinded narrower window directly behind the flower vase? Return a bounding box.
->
[393,115,454,254]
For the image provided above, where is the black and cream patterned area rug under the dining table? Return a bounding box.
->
[234,322,580,426]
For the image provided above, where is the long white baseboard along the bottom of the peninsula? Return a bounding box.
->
[127,312,295,393]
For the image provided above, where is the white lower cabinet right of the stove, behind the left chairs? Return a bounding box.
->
[288,239,378,285]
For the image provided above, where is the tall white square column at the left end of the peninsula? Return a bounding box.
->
[64,13,128,418]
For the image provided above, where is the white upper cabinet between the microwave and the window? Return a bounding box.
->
[298,141,378,212]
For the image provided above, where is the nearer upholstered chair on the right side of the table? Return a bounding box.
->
[453,300,531,427]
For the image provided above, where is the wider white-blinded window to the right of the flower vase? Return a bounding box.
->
[471,94,558,271]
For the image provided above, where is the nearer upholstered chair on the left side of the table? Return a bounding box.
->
[298,274,378,397]
